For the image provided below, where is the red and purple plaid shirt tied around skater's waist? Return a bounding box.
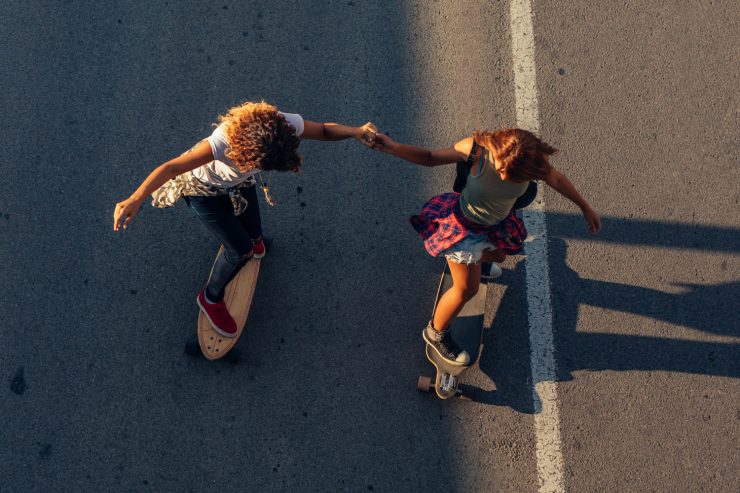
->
[409,192,527,257]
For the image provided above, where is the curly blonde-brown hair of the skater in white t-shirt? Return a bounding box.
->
[218,101,301,173]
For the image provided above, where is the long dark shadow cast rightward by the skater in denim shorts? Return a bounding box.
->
[466,214,740,413]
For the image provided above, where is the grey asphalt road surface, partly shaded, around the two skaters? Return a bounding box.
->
[0,0,740,492]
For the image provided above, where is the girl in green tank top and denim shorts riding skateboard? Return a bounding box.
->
[375,128,601,365]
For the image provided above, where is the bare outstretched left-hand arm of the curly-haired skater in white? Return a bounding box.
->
[113,140,213,231]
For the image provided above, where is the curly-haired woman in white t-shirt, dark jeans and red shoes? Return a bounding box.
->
[113,102,374,337]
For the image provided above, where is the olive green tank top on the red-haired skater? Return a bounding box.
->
[460,146,529,225]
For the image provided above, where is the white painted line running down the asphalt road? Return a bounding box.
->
[510,0,565,493]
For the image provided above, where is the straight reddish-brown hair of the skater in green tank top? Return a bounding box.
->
[473,128,558,182]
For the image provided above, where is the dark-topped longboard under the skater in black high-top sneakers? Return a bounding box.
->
[418,263,488,399]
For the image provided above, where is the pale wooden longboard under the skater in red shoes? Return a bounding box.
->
[198,246,260,360]
